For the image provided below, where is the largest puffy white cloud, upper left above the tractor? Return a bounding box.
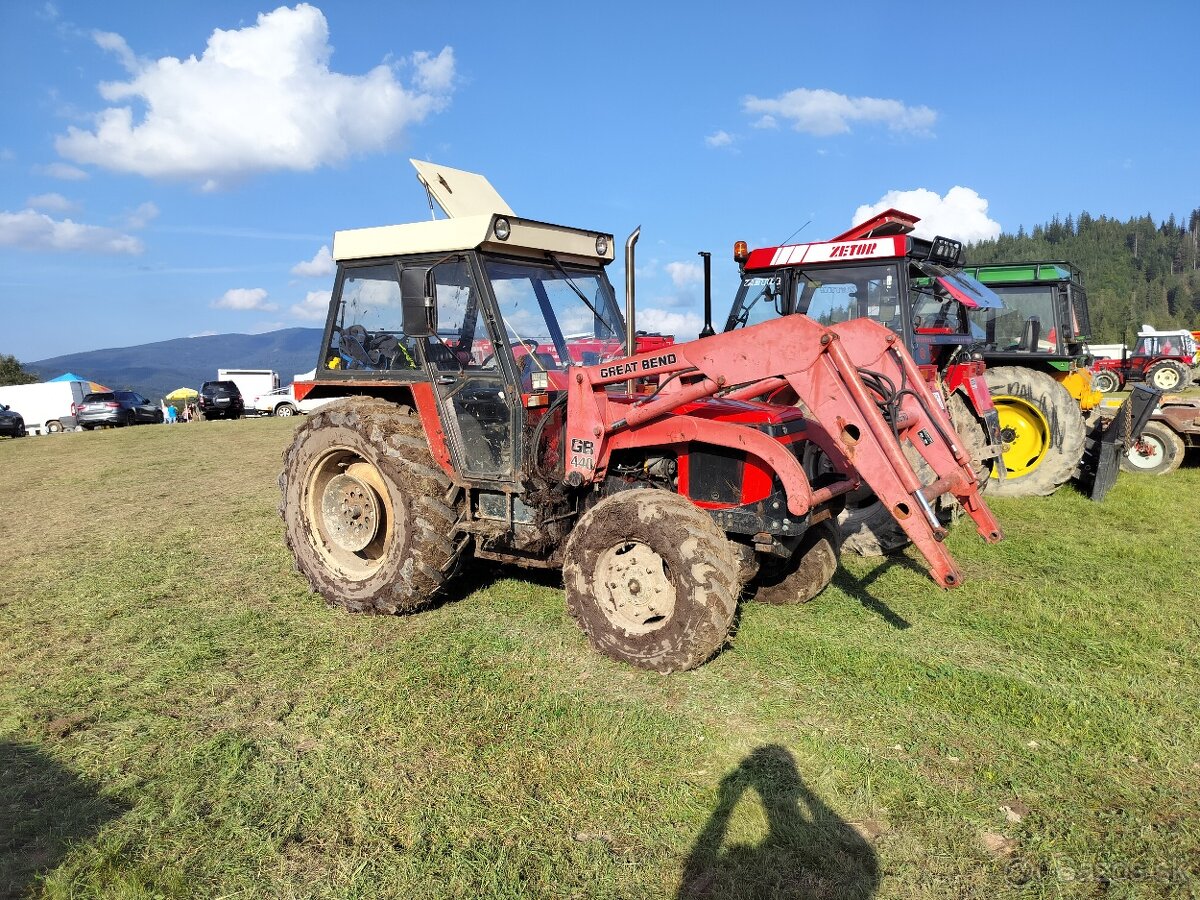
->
[55,4,455,191]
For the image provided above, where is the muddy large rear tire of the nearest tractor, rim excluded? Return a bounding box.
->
[278,397,458,613]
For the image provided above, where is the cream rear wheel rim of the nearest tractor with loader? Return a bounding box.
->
[305,448,404,581]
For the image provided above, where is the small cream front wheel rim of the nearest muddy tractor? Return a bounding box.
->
[595,541,676,635]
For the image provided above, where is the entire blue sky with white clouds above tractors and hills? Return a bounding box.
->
[0,0,1200,361]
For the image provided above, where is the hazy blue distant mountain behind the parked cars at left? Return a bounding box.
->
[23,328,322,401]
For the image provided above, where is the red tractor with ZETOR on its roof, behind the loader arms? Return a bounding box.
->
[725,209,1003,556]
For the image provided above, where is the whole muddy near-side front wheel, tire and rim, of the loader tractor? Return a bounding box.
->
[563,488,742,673]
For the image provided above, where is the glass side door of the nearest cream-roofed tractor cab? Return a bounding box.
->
[422,256,521,481]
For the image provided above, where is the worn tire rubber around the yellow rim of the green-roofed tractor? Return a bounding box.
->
[984,366,1087,497]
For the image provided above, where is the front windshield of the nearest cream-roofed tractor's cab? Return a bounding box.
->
[484,258,625,372]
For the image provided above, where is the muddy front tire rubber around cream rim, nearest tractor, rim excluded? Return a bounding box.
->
[563,488,742,673]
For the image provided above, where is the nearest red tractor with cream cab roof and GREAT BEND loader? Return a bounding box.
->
[280,163,1001,672]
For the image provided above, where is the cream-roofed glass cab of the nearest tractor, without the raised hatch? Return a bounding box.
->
[314,214,625,481]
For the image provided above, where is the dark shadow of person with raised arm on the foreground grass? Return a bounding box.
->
[677,744,880,900]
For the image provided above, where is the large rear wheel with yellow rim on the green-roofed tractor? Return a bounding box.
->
[984,366,1087,497]
